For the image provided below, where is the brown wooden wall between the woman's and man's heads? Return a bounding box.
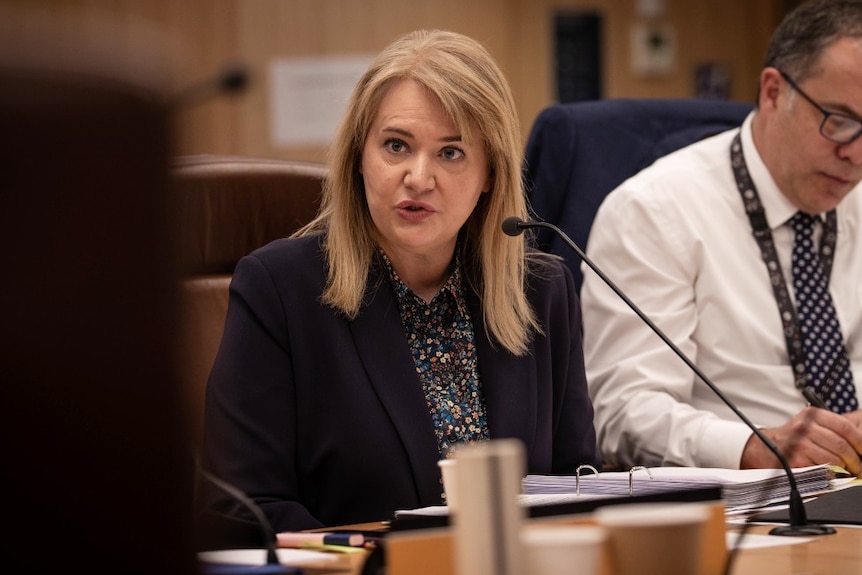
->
[512,0,783,132]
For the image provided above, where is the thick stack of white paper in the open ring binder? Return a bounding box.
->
[522,465,831,510]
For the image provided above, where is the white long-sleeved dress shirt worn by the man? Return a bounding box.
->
[581,116,862,469]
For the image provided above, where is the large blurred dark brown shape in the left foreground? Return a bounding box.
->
[0,7,195,575]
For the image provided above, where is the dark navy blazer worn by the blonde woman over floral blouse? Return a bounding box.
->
[204,235,599,531]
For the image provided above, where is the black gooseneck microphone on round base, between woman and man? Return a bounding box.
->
[503,216,835,536]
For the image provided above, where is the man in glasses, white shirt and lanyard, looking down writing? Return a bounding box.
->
[581,0,862,476]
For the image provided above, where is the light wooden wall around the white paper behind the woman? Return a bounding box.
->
[230,0,511,160]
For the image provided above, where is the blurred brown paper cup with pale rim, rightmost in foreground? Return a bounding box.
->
[595,503,711,575]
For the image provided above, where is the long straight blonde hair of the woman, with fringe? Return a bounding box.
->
[294,30,542,355]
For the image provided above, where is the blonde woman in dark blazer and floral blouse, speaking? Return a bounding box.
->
[204,30,598,530]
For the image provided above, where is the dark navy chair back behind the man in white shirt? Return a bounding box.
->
[524,98,753,289]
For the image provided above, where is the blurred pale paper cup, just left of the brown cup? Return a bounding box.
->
[521,525,607,575]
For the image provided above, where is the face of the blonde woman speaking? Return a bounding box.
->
[362,80,490,260]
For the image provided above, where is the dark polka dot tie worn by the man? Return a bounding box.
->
[790,212,858,413]
